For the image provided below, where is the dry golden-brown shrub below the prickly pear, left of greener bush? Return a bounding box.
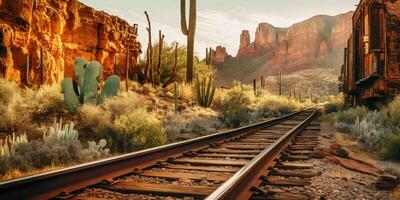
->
[78,104,112,133]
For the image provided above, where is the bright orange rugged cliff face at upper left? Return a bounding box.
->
[0,0,141,84]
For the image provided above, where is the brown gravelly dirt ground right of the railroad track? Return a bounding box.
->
[306,122,400,200]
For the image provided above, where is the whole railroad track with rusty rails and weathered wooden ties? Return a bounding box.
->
[0,109,319,199]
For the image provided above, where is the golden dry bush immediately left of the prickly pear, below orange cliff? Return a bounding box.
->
[25,85,64,115]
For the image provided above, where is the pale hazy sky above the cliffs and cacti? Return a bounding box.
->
[80,0,359,57]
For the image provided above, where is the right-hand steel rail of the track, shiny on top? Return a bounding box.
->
[206,110,317,200]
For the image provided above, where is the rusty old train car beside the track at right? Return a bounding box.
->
[339,0,400,108]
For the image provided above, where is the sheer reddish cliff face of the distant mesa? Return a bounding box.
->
[236,12,353,73]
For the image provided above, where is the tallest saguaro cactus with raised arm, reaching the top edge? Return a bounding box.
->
[181,0,197,83]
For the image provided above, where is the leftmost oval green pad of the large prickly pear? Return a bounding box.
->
[61,77,79,113]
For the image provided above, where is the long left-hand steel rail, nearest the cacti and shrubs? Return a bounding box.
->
[0,110,305,199]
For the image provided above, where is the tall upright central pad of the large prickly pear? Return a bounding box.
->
[81,62,100,104]
